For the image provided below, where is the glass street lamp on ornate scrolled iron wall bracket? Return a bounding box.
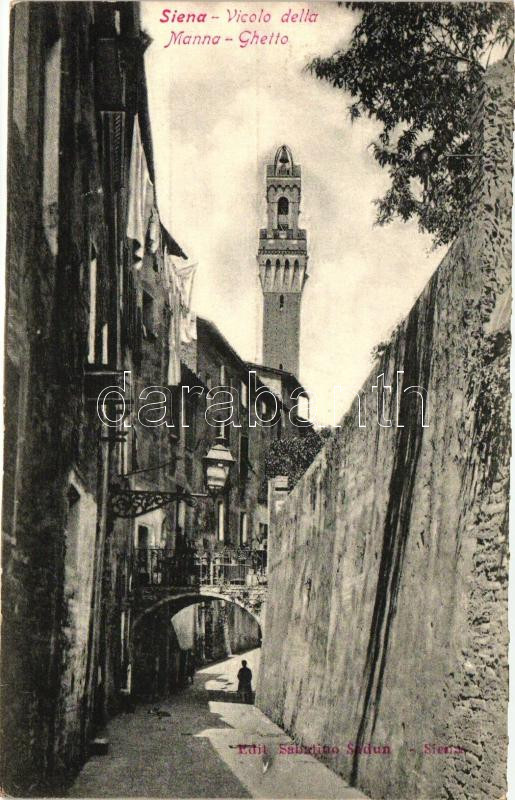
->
[109,439,234,519]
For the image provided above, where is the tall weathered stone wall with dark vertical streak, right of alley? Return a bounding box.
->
[257,63,511,800]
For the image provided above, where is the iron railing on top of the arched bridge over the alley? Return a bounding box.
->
[134,547,267,588]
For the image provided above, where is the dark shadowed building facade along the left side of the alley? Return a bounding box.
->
[1,2,199,794]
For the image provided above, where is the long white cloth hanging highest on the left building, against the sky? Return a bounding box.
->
[127,115,154,267]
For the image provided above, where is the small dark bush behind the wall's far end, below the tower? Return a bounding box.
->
[265,428,331,489]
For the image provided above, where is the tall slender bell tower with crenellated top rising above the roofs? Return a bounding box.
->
[257,144,308,376]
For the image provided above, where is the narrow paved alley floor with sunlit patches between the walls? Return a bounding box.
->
[68,650,364,800]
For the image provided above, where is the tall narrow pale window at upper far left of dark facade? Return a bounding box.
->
[43,34,61,255]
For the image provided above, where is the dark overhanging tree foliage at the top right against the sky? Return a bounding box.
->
[308,2,513,246]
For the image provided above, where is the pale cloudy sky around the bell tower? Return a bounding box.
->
[141,0,444,425]
